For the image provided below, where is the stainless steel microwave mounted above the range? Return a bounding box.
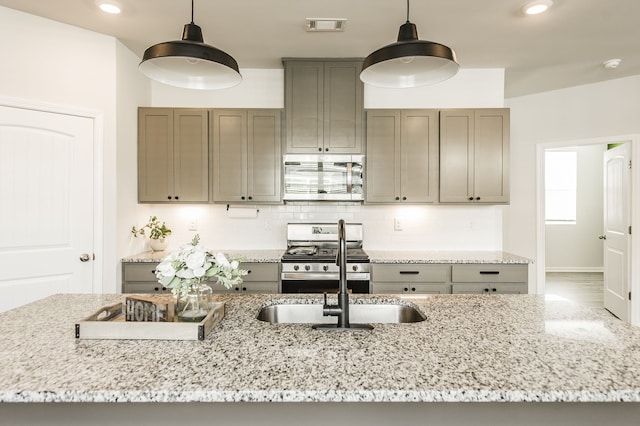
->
[283,154,364,201]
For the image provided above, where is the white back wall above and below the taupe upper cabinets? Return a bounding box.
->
[139,69,504,250]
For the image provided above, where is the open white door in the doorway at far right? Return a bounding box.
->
[601,143,631,321]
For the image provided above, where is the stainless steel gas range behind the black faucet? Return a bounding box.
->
[281,223,370,293]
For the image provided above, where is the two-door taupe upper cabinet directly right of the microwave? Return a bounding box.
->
[366,110,438,204]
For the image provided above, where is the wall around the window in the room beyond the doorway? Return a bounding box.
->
[545,145,606,272]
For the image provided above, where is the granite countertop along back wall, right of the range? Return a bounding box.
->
[366,250,533,264]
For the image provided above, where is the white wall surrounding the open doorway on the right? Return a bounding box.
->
[503,76,640,291]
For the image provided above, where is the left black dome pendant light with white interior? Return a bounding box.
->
[139,0,242,89]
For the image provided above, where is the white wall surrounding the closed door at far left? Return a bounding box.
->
[0,7,122,288]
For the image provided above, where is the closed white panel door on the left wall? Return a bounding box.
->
[0,106,94,312]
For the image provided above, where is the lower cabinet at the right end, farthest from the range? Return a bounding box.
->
[451,264,528,294]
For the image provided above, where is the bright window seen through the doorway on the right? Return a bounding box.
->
[544,150,578,224]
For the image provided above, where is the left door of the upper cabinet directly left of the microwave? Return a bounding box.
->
[211,109,247,202]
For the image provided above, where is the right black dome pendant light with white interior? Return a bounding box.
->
[360,0,460,88]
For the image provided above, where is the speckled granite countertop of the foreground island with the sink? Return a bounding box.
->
[0,295,640,402]
